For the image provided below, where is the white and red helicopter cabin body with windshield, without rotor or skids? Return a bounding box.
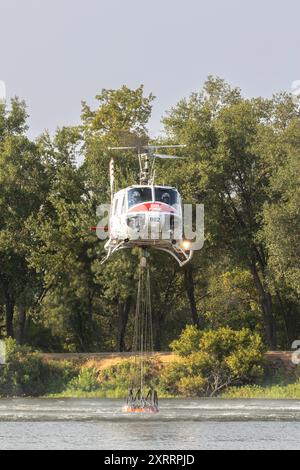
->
[107,185,182,247]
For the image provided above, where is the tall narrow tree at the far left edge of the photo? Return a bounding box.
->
[0,99,47,342]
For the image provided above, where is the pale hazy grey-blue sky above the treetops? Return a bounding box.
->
[0,0,300,136]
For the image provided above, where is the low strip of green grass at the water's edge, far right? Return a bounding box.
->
[221,381,300,400]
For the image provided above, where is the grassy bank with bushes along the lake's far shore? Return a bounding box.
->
[0,334,300,399]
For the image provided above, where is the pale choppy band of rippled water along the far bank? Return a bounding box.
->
[0,399,300,423]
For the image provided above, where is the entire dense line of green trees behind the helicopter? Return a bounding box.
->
[0,77,300,351]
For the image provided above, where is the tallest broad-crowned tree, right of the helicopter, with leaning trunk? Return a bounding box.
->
[164,77,298,349]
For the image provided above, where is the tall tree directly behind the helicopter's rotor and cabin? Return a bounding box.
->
[81,85,154,350]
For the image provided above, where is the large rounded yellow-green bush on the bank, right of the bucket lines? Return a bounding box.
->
[162,327,263,396]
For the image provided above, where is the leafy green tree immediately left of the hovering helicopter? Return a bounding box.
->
[27,128,101,351]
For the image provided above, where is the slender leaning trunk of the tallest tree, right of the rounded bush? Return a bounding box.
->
[251,261,277,351]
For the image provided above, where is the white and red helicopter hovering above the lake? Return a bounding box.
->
[101,145,193,266]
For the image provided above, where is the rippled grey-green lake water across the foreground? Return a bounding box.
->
[0,399,300,450]
